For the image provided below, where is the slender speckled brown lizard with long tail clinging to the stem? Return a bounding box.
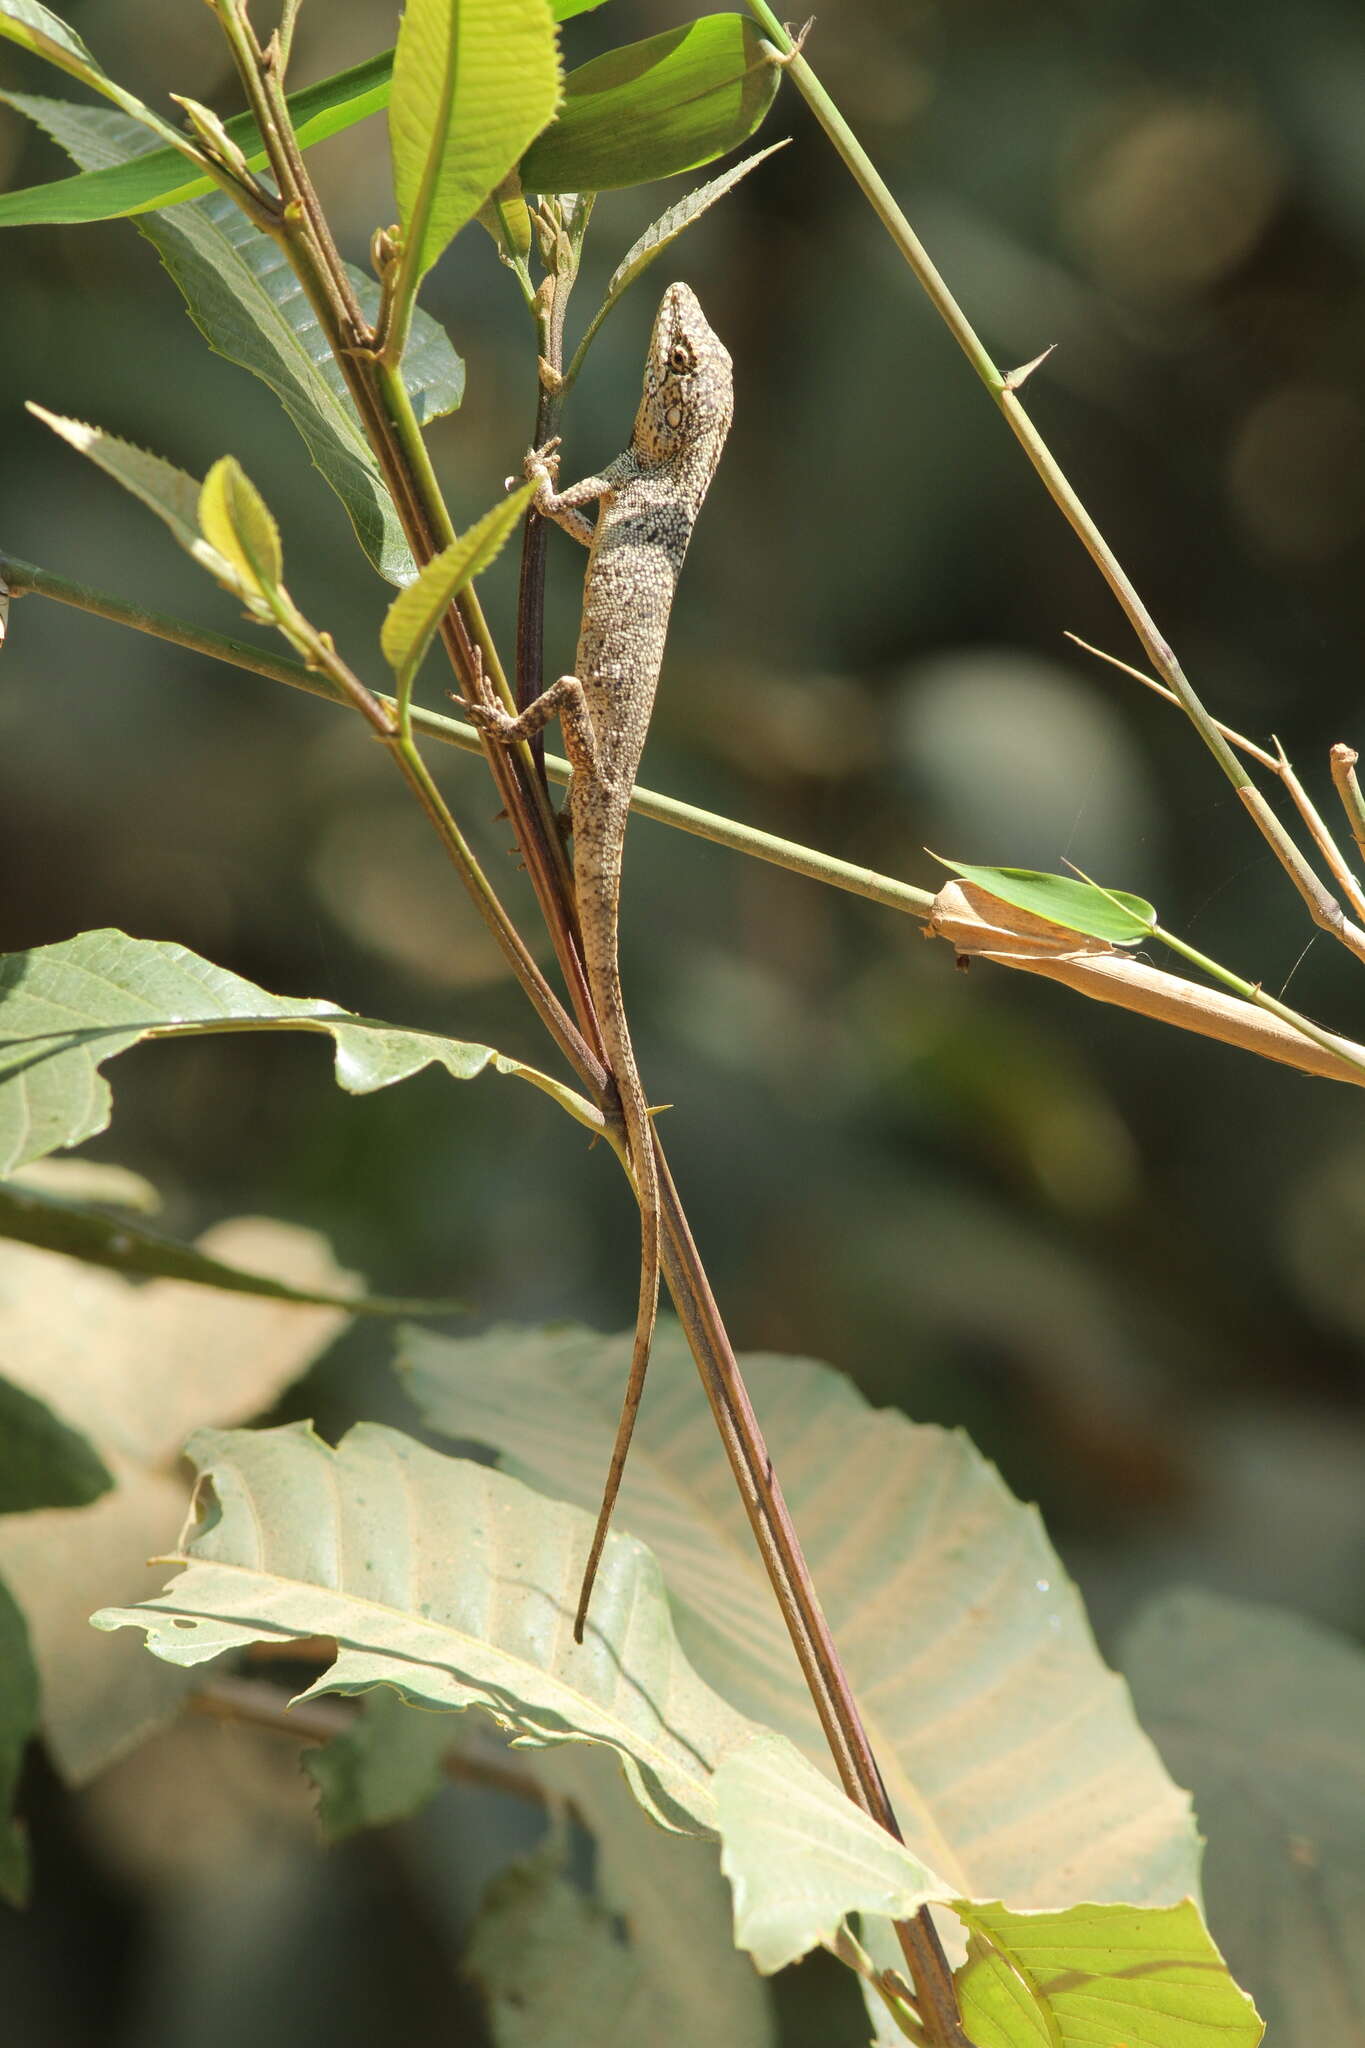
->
[467,285,735,1642]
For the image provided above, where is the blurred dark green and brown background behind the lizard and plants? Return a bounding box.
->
[0,0,1365,2048]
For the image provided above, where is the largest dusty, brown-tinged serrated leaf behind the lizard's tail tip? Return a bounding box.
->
[399,1323,1199,1907]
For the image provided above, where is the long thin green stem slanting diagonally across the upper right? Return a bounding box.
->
[747,0,1365,974]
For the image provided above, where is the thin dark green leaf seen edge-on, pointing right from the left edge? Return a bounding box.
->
[0,1159,465,1318]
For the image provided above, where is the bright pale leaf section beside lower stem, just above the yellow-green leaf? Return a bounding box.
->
[716,1735,952,1976]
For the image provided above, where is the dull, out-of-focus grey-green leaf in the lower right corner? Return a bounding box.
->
[1121,1589,1365,2048]
